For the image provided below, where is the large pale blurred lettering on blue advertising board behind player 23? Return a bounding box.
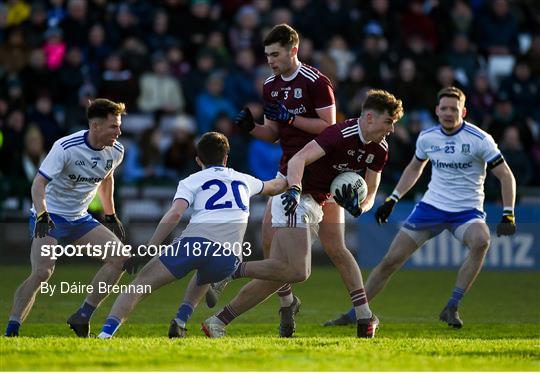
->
[411,231,538,269]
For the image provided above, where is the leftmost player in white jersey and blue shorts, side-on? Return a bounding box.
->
[5,99,127,337]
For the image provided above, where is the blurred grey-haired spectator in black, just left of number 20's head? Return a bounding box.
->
[164,115,199,181]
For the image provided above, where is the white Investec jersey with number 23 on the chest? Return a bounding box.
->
[416,122,502,212]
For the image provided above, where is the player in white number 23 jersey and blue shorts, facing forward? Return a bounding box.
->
[327,87,516,328]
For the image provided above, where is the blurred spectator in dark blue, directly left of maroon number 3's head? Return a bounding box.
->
[223,49,258,110]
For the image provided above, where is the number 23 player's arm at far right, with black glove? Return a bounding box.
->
[491,162,516,236]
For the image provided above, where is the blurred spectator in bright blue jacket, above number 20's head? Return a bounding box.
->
[196,71,237,134]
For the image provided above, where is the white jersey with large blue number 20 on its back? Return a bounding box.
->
[174,166,264,244]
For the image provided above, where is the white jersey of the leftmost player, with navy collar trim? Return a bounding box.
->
[32,130,124,220]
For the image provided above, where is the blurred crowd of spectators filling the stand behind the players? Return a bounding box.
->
[0,0,540,212]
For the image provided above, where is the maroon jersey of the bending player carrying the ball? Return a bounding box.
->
[302,119,388,204]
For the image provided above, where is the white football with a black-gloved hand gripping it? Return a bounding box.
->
[330,172,368,217]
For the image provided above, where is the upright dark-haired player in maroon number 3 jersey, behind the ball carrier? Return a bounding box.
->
[207,24,370,337]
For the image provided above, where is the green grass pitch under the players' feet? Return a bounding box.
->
[0,263,540,371]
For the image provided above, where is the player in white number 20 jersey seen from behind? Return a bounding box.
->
[98,132,287,338]
